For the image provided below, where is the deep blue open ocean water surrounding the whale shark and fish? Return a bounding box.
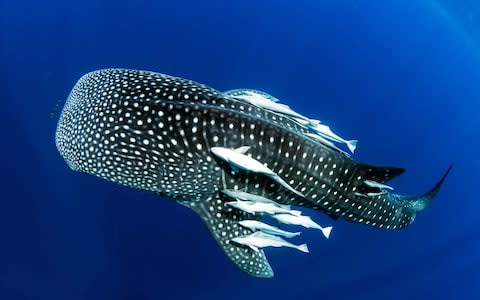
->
[0,0,480,300]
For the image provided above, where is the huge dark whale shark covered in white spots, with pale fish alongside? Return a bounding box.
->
[55,69,451,278]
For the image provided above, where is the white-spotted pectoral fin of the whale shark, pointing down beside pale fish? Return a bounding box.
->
[189,193,273,278]
